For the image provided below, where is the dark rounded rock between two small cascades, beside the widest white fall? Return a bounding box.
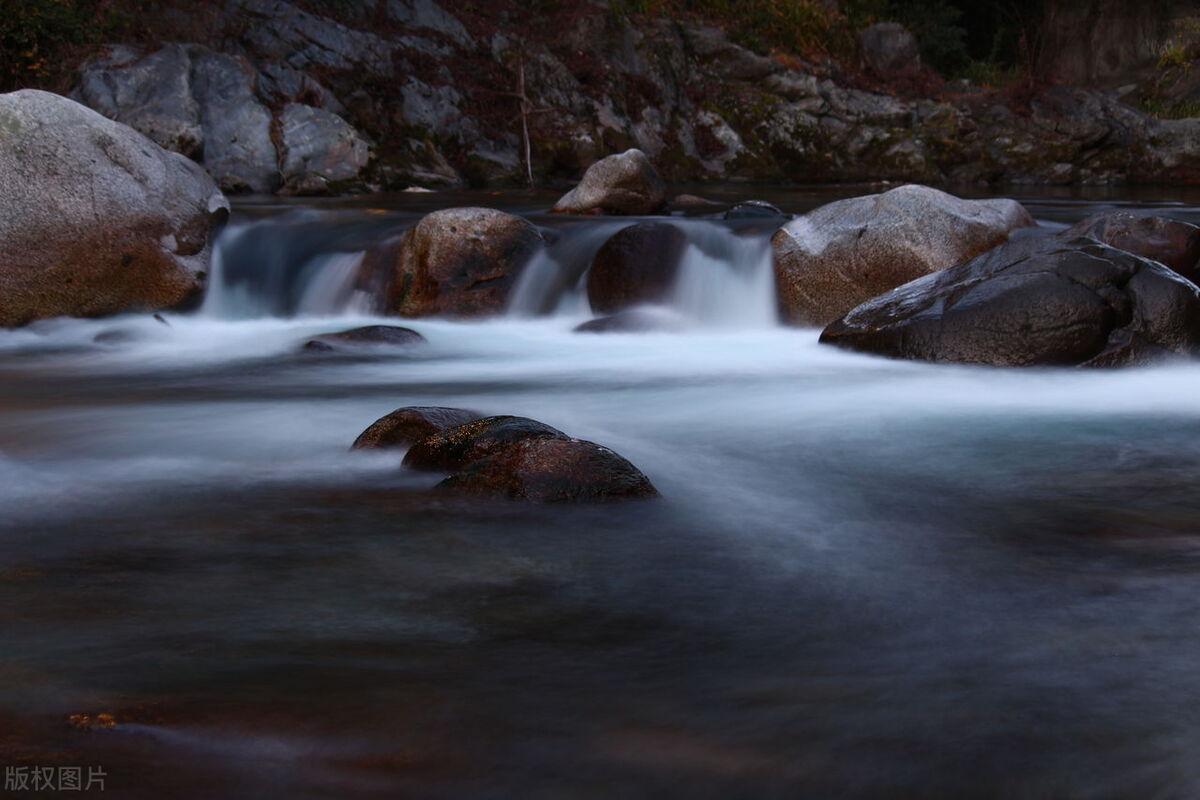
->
[588,222,688,314]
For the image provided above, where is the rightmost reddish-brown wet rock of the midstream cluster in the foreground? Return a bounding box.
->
[438,438,659,503]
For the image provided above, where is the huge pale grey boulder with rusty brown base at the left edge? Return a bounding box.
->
[0,90,229,325]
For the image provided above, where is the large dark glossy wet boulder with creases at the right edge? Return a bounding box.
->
[821,236,1200,366]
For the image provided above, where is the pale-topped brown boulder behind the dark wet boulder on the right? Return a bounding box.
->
[772,186,1033,325]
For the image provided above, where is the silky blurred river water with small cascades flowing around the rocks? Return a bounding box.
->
[7,190,1200,799]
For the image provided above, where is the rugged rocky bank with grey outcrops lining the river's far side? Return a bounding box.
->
[54,0,1200,194]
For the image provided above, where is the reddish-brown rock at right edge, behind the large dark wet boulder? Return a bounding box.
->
[1063,211,1200,283]
